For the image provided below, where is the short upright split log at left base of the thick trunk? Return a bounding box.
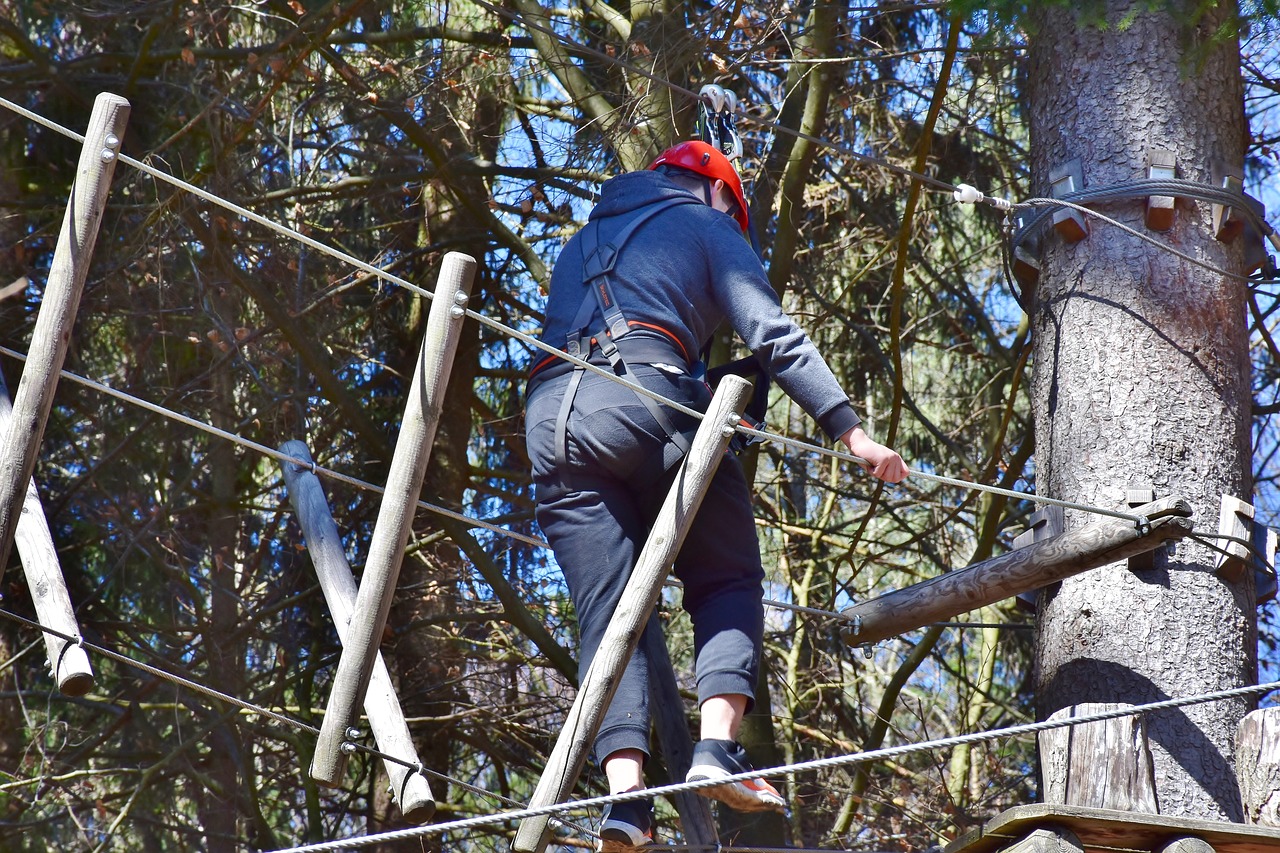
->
[1039,702,1160,815]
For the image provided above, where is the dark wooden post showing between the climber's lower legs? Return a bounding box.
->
[650,612,719,849]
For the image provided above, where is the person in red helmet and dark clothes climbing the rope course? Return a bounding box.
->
[526,141,908,852]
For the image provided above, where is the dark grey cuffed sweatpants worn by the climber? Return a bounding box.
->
[526,365,764,761]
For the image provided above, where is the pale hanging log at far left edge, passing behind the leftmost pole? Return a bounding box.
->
[0,377,93,695]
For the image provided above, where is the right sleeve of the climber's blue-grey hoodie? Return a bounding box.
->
[704,219,860,438]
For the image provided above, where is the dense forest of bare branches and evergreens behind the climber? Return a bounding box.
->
[0,0,1280,852]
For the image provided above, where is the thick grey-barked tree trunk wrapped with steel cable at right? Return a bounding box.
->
[1029,0,1257,821]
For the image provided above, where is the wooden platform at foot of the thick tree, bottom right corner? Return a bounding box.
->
[943,803,1280,853]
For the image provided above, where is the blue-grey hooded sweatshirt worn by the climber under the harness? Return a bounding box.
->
[531,172,859,438]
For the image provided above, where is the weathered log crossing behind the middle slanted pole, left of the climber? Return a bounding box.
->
[280,441,435,824]
